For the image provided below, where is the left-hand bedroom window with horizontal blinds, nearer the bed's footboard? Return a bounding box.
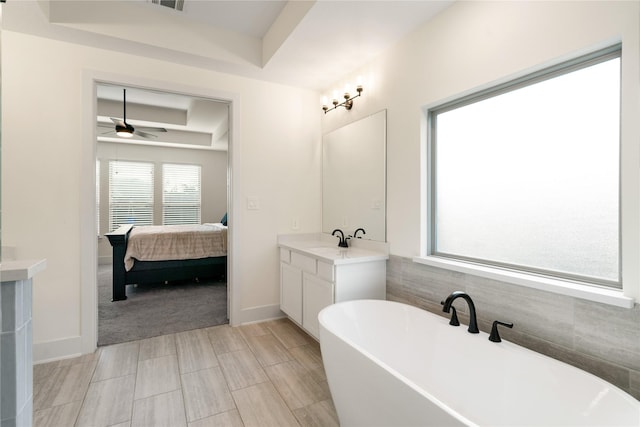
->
[109,160,153,231]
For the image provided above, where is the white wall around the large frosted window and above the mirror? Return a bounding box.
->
[322,1,640,298]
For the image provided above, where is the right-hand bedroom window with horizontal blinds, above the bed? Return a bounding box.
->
[162,163,201,225]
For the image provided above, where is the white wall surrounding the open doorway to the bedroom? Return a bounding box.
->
[2,30,321,361]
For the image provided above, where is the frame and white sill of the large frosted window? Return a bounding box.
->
[414,43,633,307]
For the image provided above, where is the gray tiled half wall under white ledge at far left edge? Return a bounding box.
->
[0,279,33,427]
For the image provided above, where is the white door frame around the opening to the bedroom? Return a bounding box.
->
[79,71,241,354]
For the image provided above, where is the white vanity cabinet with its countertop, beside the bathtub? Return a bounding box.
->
[280,247,387,339]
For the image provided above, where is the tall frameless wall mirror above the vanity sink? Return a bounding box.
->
[322,110,387,242]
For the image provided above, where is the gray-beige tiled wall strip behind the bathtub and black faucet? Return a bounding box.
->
[387,256,640,400]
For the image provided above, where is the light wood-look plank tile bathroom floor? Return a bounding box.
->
[33,319,338,427]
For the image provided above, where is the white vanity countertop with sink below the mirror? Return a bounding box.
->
[278,234,389,265]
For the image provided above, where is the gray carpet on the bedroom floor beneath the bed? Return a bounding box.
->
[98,265,228,346]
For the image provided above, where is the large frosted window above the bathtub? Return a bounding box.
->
[429,46,621,287]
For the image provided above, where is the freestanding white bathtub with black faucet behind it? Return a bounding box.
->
[319,300,640,427]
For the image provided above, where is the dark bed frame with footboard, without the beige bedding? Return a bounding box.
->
[105,225,227,301]
